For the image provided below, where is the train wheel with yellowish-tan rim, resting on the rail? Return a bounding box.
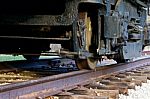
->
[76,12,98,69]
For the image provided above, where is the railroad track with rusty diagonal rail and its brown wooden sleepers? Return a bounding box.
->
[0,58,150,99]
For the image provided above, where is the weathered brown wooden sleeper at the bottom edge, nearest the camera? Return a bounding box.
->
[54,87,119,99]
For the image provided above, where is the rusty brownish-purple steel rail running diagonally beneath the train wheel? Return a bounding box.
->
[0,58,150,99]
